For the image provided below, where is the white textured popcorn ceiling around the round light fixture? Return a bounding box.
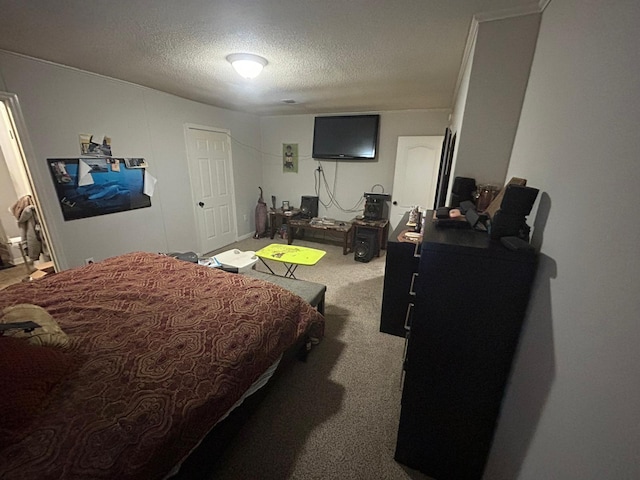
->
[0,0,539,115]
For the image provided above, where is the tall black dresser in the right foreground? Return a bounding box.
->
[395,212,537,480]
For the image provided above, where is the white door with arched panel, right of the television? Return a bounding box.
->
[390,135,444,229]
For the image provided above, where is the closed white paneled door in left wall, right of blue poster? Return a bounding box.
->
[187,126,236,255]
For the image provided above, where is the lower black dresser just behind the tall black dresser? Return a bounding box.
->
[380,213,420,337]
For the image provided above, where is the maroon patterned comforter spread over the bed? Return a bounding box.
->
[0,252,324,479]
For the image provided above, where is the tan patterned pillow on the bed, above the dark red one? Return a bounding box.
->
[0,303,69,347]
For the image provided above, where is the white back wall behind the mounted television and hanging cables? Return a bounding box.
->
[260,110,449,220]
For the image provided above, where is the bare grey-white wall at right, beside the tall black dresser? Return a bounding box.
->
[485,0,640,480]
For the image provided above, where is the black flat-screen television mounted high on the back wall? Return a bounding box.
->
[312,115,380,160]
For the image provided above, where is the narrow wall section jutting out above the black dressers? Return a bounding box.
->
[451,14,540,186]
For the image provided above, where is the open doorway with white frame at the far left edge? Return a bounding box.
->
[0,92,60,270]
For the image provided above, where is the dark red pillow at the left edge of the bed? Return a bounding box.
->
[0,336,73,450]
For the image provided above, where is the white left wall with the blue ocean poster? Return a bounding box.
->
[0,52,262,268]
